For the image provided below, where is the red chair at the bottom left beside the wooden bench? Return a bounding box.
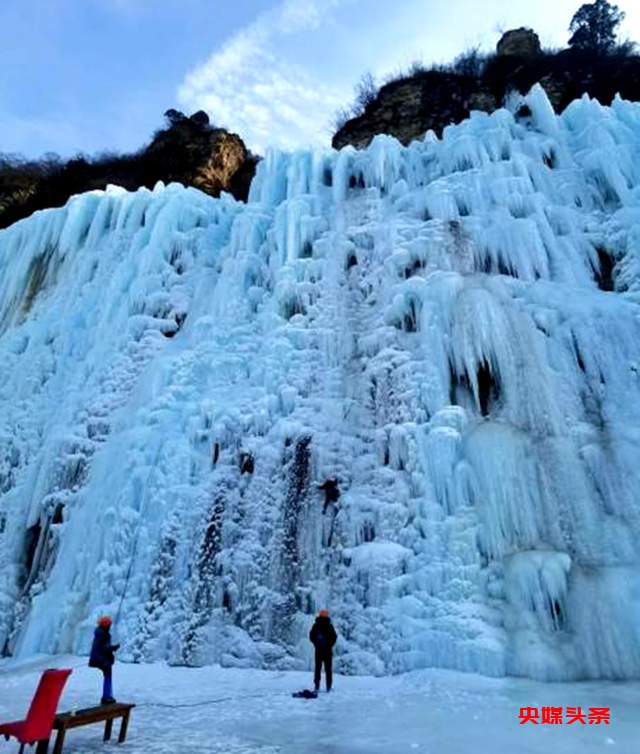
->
[0,670,71,754]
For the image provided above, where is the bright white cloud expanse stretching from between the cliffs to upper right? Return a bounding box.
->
[178,0,640,152]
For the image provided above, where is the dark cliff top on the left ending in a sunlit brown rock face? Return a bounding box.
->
[0,110,258,228]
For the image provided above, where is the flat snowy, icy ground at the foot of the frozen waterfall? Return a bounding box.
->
[0,657,640,754]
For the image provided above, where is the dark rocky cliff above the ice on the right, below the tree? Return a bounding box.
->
[332,29,640,149]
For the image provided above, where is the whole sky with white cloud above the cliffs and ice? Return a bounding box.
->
[0,0,640,156]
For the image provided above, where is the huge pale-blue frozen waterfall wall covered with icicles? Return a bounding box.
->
[0,87,640,679]
